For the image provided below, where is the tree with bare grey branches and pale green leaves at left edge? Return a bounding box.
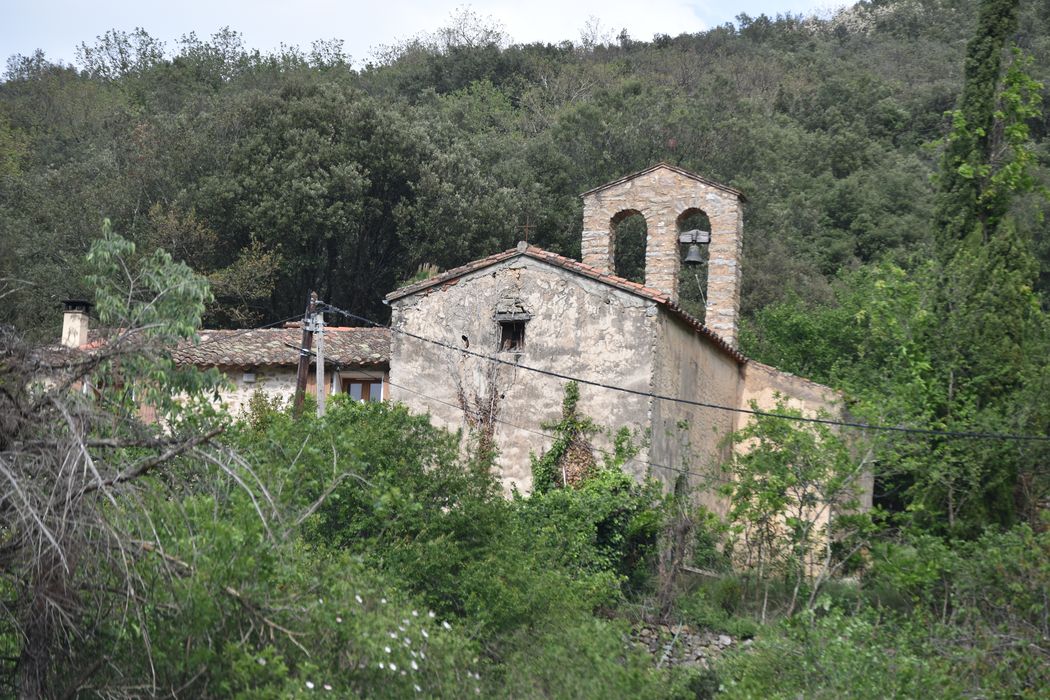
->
[0,221,225,698]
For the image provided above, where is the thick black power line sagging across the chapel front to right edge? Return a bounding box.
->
[323,303,1050,442]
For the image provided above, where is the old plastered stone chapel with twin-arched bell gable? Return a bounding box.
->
[386,164,860,512]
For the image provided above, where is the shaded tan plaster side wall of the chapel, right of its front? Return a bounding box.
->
[651,314,743,514]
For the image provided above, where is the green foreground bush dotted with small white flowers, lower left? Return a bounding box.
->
[91,474,477,698]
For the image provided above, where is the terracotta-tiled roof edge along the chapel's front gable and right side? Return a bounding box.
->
[386,242,748,364]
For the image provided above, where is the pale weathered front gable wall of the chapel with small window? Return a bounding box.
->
[390,257,656,492]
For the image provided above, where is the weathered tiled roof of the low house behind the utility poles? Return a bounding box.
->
[172,326,391,366]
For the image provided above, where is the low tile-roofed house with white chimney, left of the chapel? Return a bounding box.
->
[56,300,390,416]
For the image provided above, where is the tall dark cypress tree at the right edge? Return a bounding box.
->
[912,0,1048,534]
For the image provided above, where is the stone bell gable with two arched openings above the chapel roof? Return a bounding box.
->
[582,166,743,345]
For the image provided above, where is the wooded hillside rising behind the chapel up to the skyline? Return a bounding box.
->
[0,1,1047,339]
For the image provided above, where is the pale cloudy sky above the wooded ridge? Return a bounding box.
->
[0,0,849,66]
